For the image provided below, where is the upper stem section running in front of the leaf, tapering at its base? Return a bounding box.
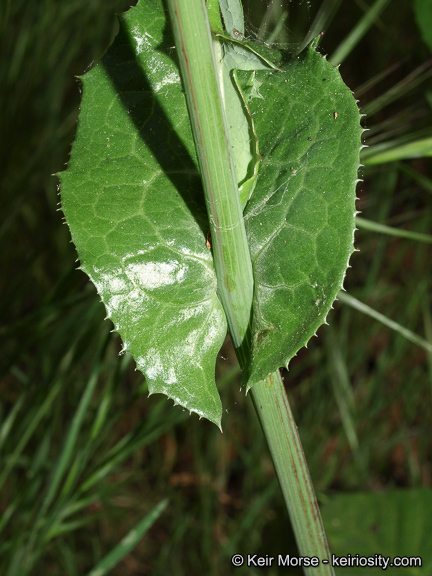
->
[168,0,253,366]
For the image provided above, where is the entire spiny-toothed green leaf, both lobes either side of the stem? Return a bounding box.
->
[61,1,361,424]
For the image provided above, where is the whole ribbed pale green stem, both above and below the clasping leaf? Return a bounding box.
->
[167,0,333,576]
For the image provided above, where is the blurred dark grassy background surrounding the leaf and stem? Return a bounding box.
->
[0,0,432,576]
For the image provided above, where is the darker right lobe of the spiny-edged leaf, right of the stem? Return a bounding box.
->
[238,47,362,385]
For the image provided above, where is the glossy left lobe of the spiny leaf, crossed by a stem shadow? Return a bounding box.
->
[61,2,226,425]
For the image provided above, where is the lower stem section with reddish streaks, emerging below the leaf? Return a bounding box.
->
[251,370,334,576]
